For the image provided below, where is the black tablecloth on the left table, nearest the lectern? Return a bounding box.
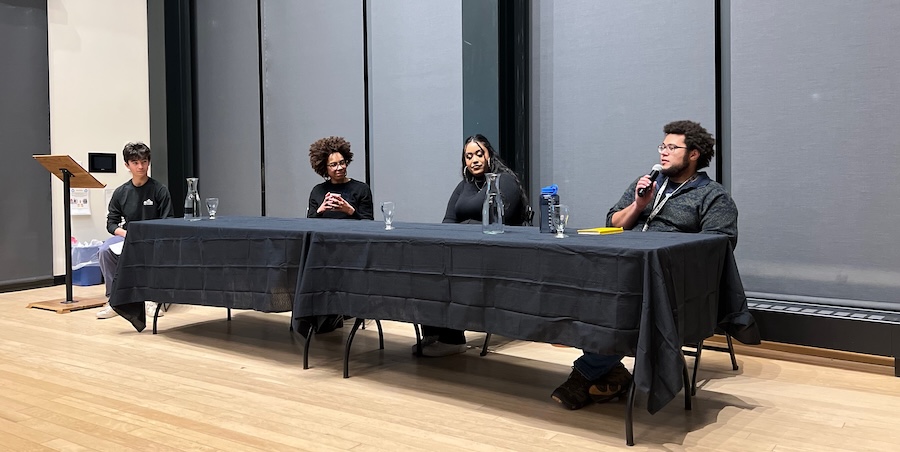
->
[109,217,326,331]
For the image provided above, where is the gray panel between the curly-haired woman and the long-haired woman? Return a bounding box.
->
[368,0,464,223]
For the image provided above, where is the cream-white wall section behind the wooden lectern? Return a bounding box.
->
[47,0,152,275]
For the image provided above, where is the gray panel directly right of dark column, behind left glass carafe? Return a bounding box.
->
[192,0,262,215]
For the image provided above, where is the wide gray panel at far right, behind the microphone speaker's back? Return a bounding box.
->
[730,0,900,309]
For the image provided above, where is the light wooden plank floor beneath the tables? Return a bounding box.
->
[0,286,900,451]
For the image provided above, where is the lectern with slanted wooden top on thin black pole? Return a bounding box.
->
[29,155,106,312]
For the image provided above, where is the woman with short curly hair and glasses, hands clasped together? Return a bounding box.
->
[306,137,375,220]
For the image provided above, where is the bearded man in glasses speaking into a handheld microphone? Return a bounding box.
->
[551,121,738,410]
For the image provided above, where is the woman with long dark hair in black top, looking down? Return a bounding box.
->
[413,134,528,356]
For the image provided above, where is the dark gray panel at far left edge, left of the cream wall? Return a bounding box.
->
[0,0,51,286]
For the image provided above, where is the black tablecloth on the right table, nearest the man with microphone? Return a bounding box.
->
[293,223,758,413]
